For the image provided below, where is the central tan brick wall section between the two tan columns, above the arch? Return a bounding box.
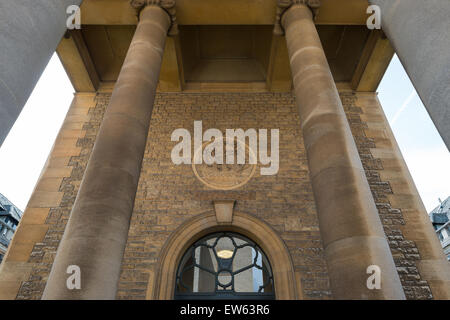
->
[117,93,330,299]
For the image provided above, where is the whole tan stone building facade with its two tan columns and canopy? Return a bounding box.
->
[0,0,450,299]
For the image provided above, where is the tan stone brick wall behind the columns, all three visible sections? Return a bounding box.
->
[0,90,445,299]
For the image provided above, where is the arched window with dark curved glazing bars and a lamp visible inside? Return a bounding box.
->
[175,232,275,299]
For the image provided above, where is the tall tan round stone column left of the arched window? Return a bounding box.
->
[43,0,174,299]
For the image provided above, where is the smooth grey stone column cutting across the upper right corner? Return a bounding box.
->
[369,0,450,150]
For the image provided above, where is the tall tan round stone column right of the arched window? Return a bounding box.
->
[279,0,405,299]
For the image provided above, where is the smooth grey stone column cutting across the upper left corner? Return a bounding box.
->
[0,0,81,146]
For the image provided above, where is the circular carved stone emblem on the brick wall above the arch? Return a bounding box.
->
[192,141,257,190]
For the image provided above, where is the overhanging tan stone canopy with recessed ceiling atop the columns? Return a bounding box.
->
[58,0,386,92]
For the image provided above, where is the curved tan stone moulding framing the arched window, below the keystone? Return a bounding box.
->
[147,211,301,300]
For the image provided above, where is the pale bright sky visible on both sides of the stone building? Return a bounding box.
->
[0,54,450,212]
